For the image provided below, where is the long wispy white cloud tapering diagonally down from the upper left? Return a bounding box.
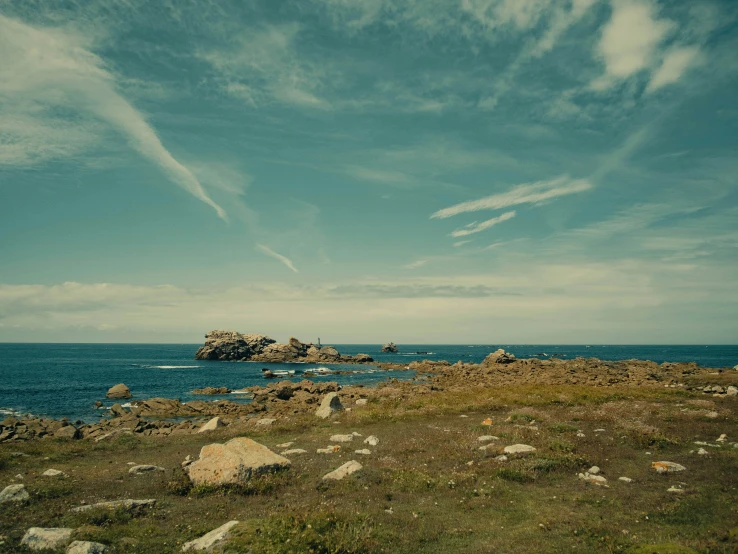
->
[0,15,227,220]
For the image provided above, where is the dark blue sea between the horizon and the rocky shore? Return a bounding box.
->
[0,343,738,422]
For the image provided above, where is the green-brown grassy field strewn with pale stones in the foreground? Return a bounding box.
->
[0,386,738,554]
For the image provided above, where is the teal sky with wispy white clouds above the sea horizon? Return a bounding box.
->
[0,0,738,344]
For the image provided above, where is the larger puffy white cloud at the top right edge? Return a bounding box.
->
[591,0,675,90]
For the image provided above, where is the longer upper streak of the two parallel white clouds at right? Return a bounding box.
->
[431,175,592,219]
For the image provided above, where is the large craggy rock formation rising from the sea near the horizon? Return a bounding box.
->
[195,331,373,363]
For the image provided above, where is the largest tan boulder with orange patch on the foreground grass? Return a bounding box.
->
[186,437,291,485]
